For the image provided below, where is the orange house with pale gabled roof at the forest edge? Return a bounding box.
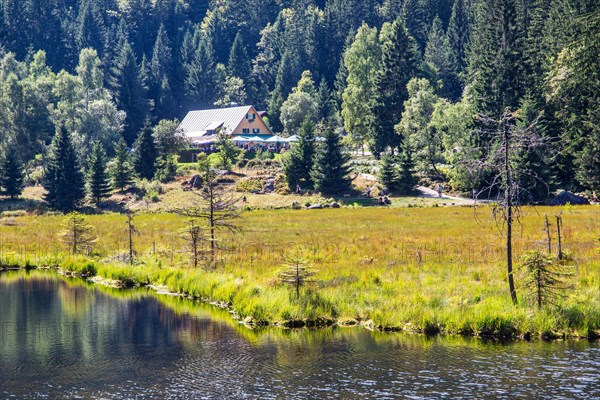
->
[179,106,273,144]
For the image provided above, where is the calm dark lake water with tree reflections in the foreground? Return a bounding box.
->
[0,272,600,399]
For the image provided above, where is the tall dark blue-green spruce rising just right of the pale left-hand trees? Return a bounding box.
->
[110,40,152,145]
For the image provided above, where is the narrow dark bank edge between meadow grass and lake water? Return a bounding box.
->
[0,265,600,342]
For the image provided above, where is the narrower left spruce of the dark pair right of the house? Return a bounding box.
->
[284,118,315,190]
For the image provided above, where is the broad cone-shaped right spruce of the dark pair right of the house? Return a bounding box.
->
[310,127,351,194]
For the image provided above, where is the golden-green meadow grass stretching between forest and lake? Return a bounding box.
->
[0,207,600,336]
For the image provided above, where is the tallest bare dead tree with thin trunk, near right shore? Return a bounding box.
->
[472,109,546,304]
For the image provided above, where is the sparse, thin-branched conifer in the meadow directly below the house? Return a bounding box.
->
[175,170,241,265]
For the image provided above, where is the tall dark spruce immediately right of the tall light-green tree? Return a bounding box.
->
[371,19,420,156]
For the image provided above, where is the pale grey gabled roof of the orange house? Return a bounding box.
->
[179,106,252,137]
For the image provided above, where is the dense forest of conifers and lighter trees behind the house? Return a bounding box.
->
[0,0,600,205]
